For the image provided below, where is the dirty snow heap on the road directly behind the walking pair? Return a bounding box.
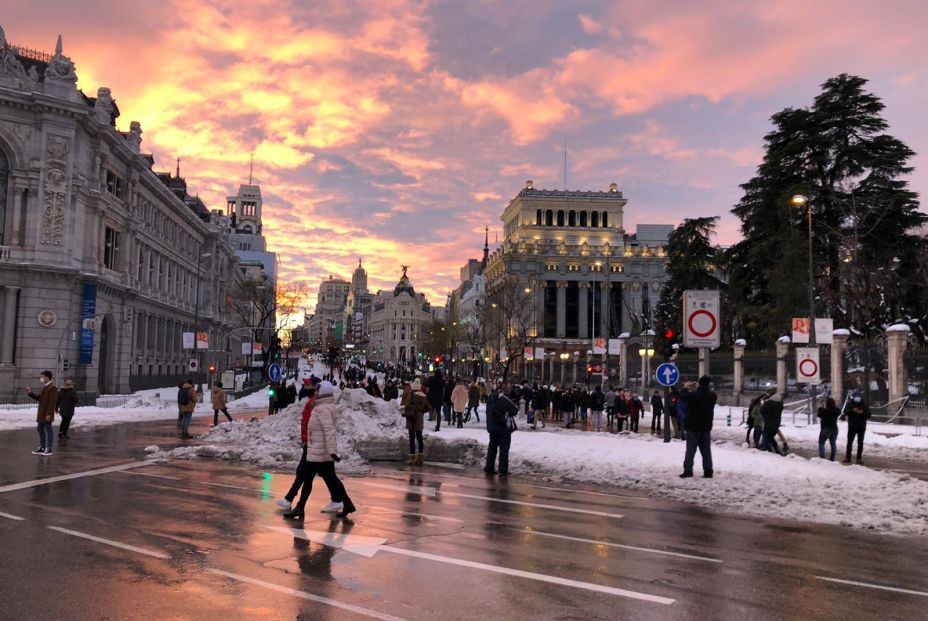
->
[148,389,406,473]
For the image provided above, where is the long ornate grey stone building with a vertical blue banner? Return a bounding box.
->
[0,29,250,402]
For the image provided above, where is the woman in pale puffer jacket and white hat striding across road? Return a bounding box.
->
[284,382,357,520]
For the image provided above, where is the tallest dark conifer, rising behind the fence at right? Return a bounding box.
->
[728,74,926,346]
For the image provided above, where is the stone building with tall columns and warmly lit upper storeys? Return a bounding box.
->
[485,181,673,370]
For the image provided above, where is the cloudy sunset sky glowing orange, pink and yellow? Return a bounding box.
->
[0,0,928,307]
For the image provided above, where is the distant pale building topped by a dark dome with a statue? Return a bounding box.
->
[367,267,435,368]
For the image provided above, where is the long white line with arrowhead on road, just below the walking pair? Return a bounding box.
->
[265,526,675,605]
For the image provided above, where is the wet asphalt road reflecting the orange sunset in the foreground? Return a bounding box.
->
[0,412,928,621]
